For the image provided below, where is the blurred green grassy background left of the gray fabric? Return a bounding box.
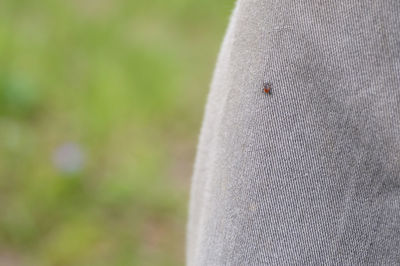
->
[0,0,234,265]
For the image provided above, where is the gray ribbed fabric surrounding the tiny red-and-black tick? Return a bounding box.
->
[187,0,400,265]
